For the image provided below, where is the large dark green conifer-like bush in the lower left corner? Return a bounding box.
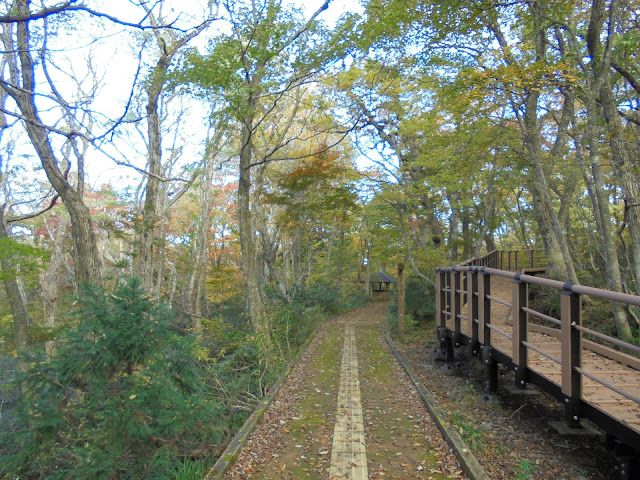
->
[0,278,220,479]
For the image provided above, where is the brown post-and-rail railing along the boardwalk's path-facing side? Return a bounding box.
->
[436,251,640,450]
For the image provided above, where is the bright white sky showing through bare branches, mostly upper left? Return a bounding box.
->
[21,0,362,188]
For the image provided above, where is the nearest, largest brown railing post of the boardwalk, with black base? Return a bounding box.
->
[560,283,582,428]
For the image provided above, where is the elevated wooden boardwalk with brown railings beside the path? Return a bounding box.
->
[436,251,640,478]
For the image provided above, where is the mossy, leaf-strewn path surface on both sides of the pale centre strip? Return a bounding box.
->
[244,305,455,480]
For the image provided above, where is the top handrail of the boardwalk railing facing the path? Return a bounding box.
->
[436,266,640,307]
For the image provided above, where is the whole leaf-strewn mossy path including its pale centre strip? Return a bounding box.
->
[225,302,464,480]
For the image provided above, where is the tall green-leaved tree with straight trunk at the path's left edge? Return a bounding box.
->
[182,0,348,338]
